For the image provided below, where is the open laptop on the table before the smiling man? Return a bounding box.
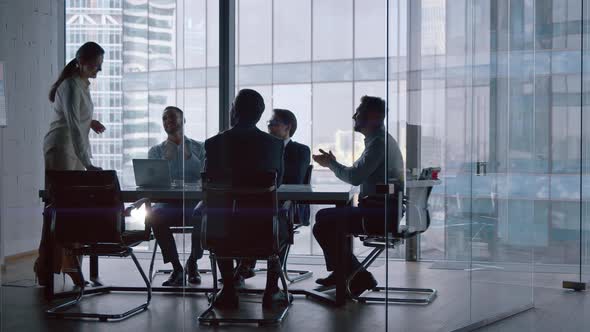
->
[133,159,172,188]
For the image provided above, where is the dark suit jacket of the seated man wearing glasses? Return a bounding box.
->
[283,140,311,226]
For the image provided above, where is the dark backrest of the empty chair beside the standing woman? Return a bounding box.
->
[45,171,125,246]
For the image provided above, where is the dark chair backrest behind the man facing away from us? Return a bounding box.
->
[201,172,279,258]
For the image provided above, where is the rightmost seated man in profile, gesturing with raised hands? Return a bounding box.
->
[313,96,404,295]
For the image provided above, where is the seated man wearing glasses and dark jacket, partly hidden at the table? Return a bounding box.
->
[236,108,311,284]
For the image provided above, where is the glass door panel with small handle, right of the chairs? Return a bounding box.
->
[467,1,547,322]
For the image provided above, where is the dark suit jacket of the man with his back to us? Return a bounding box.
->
[205,125,284,185]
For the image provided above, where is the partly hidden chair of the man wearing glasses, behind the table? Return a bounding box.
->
[254,165,313,283]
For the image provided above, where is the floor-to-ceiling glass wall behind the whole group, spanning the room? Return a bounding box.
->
[56,0,590,331]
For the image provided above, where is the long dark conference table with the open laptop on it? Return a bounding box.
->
[39,184,357,306]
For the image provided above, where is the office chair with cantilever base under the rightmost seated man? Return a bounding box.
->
[347,185,437,305]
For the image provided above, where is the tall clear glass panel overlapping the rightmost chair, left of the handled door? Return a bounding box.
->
[387,0,473,331]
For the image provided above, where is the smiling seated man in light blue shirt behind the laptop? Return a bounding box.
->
[148,106,205,286]
